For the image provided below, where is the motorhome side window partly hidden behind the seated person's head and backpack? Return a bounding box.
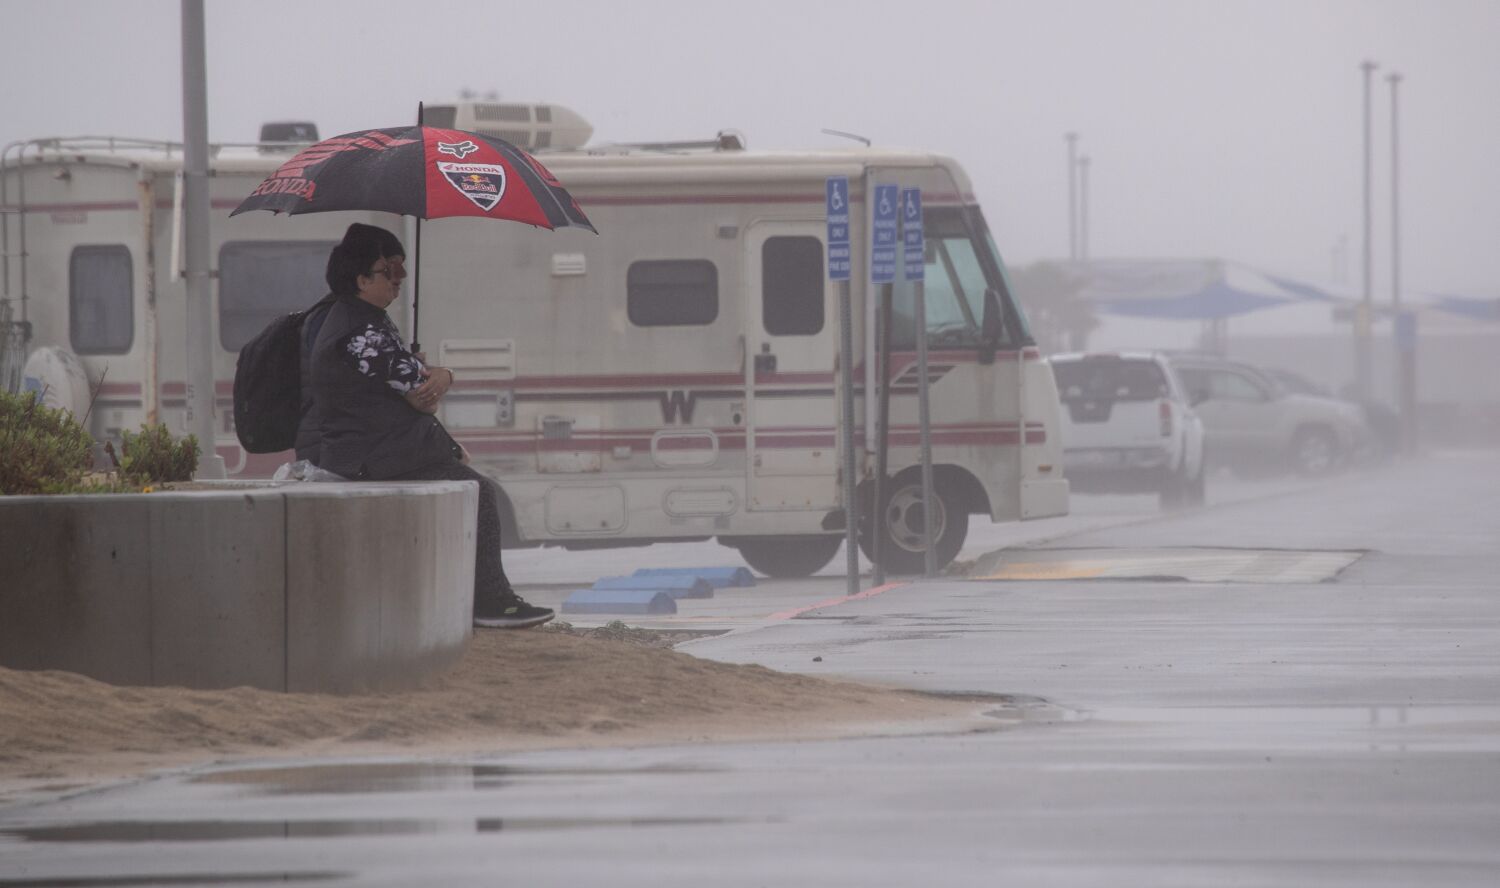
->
[219,240,335,351]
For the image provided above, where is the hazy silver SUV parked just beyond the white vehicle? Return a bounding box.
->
[1170,356,1371,476]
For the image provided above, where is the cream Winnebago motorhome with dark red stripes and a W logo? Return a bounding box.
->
[0,105,1068,576]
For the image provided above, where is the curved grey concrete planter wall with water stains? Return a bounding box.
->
[0,482,479,693]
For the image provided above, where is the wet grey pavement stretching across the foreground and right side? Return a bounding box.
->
[0,453,1500,888]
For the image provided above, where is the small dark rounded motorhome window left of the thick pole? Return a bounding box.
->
[68,245,135,354]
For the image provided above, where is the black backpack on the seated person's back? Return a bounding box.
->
[234,294,335,453]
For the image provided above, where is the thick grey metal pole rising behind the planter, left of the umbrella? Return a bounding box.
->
[182,0,225,479]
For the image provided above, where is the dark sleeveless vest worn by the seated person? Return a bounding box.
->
[307,296,461,482]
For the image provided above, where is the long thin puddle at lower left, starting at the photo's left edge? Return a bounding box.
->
[0,818,749,845]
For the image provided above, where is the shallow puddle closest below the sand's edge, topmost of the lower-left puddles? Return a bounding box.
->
[189,762,722,795]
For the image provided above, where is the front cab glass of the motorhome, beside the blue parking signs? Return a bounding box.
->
[891,207,1025,350]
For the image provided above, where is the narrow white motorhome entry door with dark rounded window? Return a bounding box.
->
[743,222,839,512]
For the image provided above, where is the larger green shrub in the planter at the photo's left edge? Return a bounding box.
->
[0,390,93,495]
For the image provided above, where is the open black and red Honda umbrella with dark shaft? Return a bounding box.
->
[230,117,597,351]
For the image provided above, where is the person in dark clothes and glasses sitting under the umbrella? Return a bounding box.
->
[307,222,554,629]
